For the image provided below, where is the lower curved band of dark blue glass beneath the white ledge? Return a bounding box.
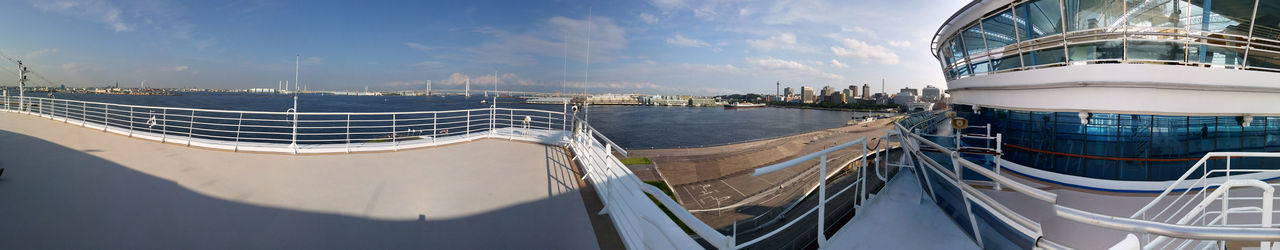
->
[952,105,1280,181]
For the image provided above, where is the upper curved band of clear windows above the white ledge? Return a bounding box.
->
[937,0,1280,79]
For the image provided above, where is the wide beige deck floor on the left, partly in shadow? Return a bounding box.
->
[0,113,608,249]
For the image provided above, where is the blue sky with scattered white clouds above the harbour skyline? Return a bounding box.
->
[0,0,966,95]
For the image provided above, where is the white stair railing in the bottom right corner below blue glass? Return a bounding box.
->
[1129,153,1280,249]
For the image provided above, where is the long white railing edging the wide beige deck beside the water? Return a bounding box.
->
[4,96,567,154]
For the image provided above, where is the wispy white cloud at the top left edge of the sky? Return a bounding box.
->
[35,0,133,32]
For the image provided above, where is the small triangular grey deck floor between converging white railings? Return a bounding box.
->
[827,169,978,250]
